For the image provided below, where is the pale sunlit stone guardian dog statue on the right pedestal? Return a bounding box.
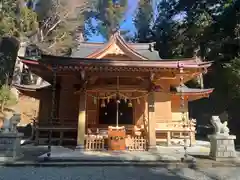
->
[210,116,229,135]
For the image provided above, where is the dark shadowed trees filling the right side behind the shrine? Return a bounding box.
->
[135,0,240,131]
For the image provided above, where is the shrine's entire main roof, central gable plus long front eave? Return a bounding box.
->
[19,33,211,72]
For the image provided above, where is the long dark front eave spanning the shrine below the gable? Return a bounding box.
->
[19,55,211,69]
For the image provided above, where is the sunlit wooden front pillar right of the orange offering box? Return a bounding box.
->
[148,93,156,150]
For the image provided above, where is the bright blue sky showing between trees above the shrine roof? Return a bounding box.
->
[88,0,138,42]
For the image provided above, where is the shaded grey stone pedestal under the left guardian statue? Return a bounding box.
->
[0,132,23,162]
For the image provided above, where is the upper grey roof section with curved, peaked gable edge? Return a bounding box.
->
[72,32,161,60]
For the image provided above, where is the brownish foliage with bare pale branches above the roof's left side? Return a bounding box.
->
[35,0,91,55]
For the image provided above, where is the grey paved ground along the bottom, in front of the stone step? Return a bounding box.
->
[0,167,240,180]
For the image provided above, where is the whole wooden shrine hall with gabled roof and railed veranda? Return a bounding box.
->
[15,33,213,150]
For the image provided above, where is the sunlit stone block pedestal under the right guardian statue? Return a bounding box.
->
[208,135,236,161]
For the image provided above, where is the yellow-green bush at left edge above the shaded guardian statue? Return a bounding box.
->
[0,85,17,112]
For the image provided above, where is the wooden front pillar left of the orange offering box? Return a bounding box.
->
[77,92,86,150]
